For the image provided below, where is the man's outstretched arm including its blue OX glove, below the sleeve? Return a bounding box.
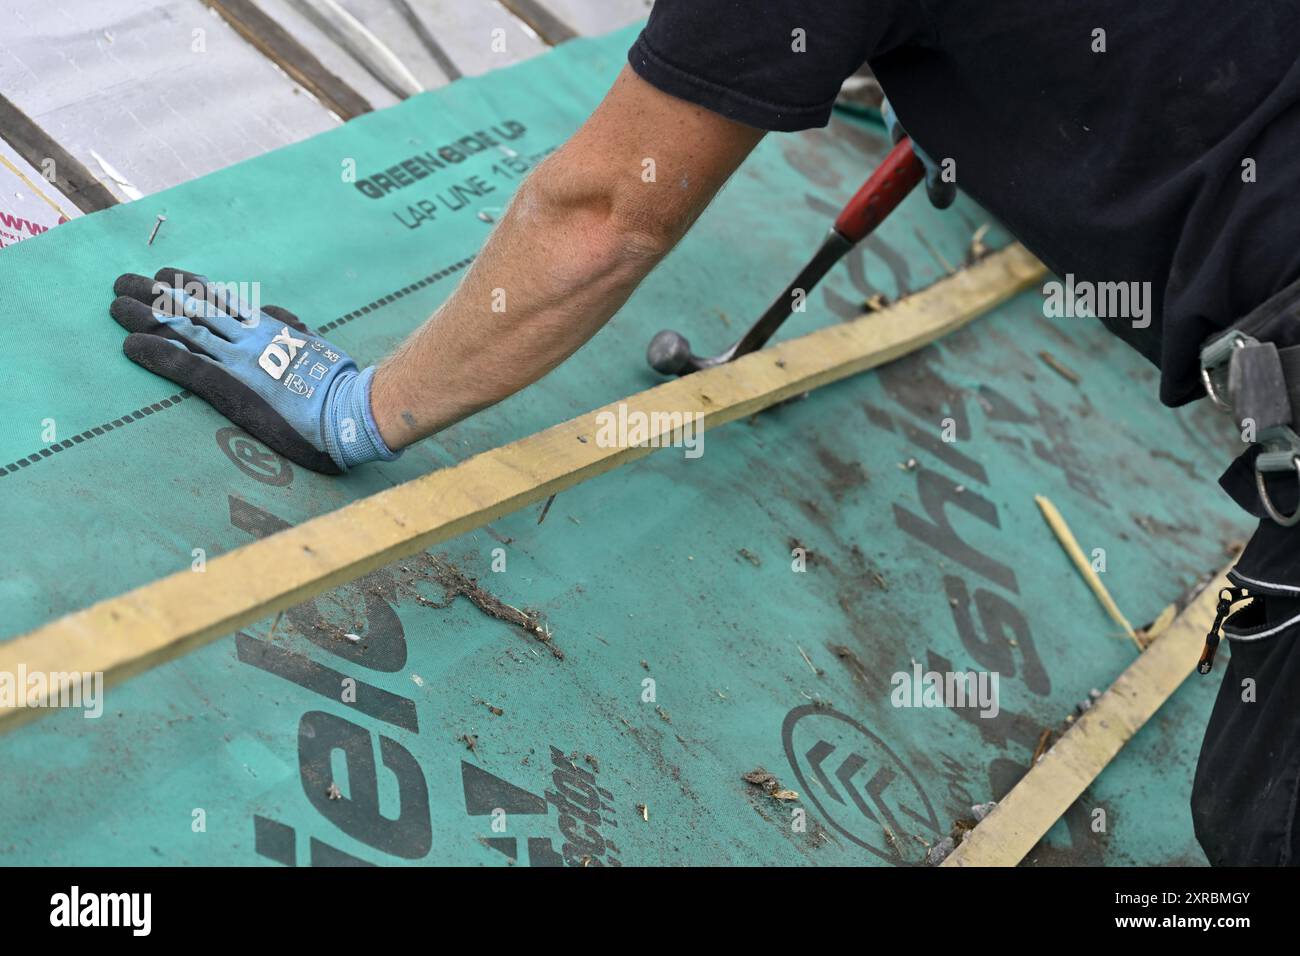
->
[109,68,762,473]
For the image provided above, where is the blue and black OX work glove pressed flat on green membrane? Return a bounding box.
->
[109,269,398,475]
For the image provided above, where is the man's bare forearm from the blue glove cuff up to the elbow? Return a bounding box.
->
[372,157,672,449]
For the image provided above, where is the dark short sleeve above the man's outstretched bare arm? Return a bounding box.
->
[628,0,928,131]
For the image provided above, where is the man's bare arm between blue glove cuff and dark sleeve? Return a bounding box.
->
[371,66,763,449]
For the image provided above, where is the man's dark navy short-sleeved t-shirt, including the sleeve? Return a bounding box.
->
[628,0,1300,405]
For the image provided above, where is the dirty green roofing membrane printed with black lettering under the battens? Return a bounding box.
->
[0,30,1244,865]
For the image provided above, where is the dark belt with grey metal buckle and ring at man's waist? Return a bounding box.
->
[1201,282,1300,528]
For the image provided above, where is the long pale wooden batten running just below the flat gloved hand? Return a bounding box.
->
[0,245,1045,730]
